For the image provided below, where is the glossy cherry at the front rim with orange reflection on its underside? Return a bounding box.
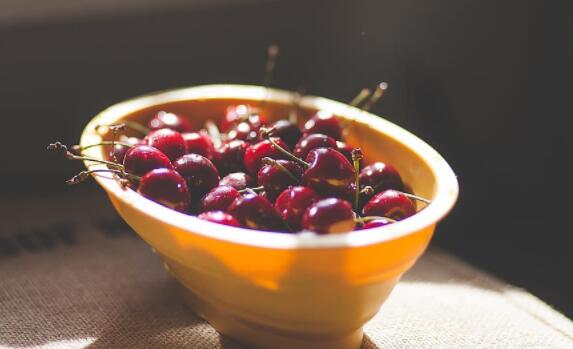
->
[302,198,356,234]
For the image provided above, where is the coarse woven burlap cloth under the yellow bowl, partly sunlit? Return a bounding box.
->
[0,194,573,349]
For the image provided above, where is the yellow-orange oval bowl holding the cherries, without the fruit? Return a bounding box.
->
[81,85,458,349]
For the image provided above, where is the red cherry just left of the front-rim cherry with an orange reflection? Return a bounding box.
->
[275,186,320,231]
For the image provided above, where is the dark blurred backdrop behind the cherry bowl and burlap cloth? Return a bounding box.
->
[0,0,573,317]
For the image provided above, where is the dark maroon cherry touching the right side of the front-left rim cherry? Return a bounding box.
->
[173,154,219,197]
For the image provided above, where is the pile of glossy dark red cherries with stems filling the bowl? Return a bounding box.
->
[48,105,428,234]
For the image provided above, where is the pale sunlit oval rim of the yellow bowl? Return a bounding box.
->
[80,84,459,249]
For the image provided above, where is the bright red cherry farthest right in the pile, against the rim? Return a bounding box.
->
[362,189,416,220]
